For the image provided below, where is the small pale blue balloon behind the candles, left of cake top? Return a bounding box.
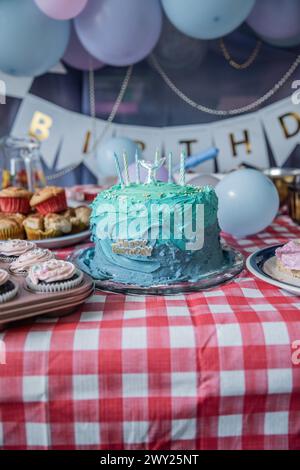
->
[96,137,140,179]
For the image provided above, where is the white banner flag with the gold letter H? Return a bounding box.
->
[212,114,269,171]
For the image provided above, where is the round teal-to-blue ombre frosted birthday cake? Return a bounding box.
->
[84,153,225,287]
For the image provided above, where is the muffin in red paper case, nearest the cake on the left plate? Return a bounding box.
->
[30,186,67,215]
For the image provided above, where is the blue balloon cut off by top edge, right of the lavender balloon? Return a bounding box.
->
[162,0,255,39]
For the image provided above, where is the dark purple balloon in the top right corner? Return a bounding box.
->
[247,0,300,40]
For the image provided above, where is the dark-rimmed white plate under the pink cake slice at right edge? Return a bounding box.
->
[246,244,300,295]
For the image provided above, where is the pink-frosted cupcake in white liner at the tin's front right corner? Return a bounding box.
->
[26,259,83,293]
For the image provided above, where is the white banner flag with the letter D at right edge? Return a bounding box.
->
[259,97,300,167]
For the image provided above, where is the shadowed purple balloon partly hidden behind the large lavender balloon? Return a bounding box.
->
[62,26,105,70]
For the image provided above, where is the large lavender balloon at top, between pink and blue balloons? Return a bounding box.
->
[75,0,162,66]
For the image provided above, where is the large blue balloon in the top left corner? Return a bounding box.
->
[0,0,70,77]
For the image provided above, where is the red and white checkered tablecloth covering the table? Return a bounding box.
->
[0,216,300,450]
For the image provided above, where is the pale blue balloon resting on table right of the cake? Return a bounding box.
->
[216,170,279,238]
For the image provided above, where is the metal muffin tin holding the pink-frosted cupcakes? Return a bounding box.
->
[0,261,94,330]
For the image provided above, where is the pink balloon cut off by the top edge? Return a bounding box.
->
[34,0,88,20]
